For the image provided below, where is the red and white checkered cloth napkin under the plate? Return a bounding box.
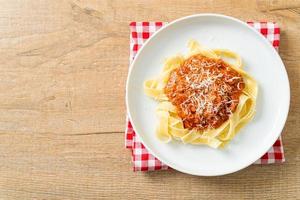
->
[125,22,285,171]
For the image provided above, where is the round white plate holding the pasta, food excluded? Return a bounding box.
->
[126,14,290,176]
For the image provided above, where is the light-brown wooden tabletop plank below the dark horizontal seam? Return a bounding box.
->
[0,133,300,199]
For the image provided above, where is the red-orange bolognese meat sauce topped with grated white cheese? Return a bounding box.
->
[164,54,245,131]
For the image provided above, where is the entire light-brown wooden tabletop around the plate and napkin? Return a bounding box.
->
[0,0,300,199]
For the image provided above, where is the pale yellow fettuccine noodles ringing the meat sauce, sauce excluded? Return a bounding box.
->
[144,40,257,148]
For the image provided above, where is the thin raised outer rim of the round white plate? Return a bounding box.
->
[125,13,290,176]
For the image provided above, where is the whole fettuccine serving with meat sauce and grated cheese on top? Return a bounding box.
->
[144,40,257,148]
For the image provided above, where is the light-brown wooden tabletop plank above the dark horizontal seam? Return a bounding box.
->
[0,1,300,133]
